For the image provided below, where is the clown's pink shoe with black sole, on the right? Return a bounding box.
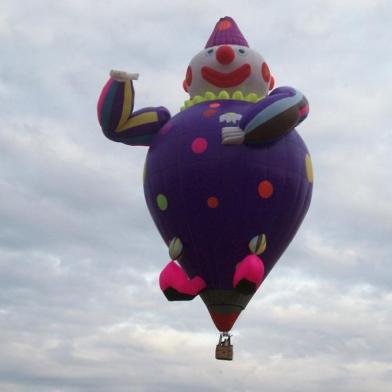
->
[233,254,264,295]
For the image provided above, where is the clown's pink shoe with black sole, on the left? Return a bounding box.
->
[159,261,207,301]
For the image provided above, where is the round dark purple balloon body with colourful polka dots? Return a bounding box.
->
[144,100,312,290]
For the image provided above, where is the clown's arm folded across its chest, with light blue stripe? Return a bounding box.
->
[222,87,309,144]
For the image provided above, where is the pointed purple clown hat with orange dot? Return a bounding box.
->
[205,16,249,49]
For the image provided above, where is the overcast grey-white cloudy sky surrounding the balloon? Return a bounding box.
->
[0,0,392,392]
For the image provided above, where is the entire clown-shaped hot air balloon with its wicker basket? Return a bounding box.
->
[98,17,313,359]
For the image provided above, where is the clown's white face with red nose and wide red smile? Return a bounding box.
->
[183,45,274,98]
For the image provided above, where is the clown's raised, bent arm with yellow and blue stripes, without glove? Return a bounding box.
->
[97,77,170,146]
